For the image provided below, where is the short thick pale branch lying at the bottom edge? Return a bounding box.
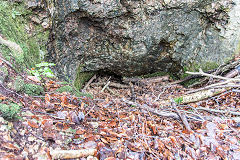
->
[50,149,97,159]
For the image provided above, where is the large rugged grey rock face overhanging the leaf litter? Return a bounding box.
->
[47,0,240,79]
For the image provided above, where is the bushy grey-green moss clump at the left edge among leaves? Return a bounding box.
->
[0,103,20,120]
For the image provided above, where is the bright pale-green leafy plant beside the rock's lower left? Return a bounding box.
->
[30,62,55,80]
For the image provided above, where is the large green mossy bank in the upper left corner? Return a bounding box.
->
[0,0,39,70]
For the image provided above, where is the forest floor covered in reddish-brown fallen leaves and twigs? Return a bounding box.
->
[0,57,240,160]
